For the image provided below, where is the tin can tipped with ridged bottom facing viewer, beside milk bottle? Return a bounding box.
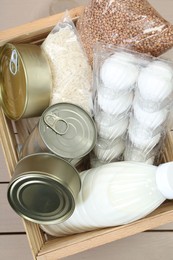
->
[7,153,81,224]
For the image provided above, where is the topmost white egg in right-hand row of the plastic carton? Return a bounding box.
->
[137,59,173,112]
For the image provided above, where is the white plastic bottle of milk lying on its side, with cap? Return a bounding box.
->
[41,162,173,236]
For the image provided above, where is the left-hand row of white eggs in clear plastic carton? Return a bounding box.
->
[93,43,139,162]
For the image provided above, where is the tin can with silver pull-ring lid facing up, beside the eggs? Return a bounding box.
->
[20,103,97,169]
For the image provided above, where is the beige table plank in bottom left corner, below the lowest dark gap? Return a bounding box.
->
[0,234,33,260]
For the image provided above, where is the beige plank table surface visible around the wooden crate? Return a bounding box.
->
[0,0,173,260]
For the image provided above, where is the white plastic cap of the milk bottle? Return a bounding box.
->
[156,162,173,199]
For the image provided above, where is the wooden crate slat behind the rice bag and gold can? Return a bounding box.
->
[0,6,84,46]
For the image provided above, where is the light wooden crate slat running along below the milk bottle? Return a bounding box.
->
[37,202,173,260]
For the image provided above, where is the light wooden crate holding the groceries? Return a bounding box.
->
[0,7,173,260]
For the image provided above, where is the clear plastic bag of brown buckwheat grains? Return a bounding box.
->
[77,0,173,62]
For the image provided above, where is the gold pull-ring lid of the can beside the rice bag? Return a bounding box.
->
[0,44,27,120]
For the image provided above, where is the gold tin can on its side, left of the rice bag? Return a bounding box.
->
[0,43,52,120]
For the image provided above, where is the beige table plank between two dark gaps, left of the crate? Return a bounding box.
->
[0,184,25,233]
